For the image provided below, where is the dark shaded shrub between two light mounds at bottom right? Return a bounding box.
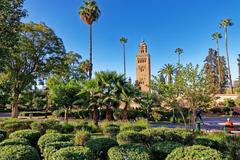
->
[152,141,183,160]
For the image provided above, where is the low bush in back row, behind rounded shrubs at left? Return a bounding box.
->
[31,120,61,135]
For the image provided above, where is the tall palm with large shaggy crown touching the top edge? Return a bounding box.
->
[79,0,101,79]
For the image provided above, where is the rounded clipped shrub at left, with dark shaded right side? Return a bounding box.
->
[9,130,41,146]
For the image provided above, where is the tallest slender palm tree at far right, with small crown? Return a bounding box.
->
[219,18,234,94]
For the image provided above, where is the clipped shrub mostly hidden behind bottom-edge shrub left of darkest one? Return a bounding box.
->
[43,142,73,159]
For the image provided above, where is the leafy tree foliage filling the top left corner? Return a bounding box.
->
[0,0,26,71]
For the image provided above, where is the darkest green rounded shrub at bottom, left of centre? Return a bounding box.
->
[85,138,118,160]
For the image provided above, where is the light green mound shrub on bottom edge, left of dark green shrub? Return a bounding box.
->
[49,146,94,160]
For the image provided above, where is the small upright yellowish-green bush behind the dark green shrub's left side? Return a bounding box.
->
[74,130,91,145]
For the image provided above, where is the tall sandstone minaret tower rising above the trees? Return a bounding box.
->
[136,41,151,92]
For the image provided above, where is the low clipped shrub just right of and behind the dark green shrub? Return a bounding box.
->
[117,131,146,144]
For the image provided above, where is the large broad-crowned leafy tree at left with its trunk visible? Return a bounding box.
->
[0,22,65,117]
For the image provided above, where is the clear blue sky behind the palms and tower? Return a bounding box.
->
[24,0,240,80]
